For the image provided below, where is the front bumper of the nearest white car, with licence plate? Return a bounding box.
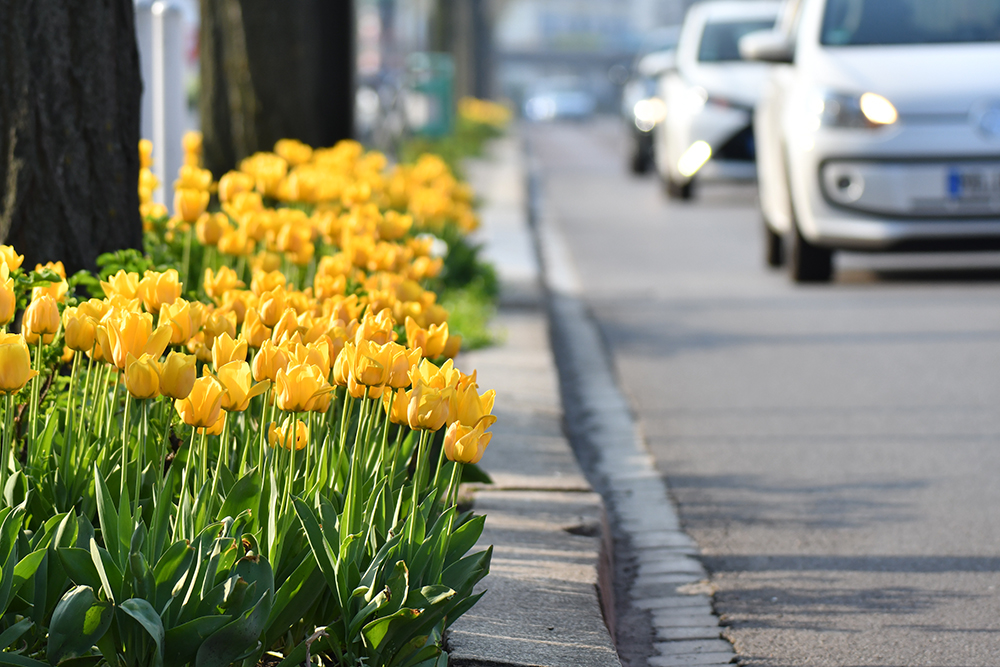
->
[788,119,1000,250]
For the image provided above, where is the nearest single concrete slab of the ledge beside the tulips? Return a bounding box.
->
[448,490,620,667]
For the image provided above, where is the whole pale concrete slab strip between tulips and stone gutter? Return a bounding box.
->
[447,137,620,667]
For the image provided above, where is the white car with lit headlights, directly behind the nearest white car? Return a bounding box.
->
[653,0,781,199]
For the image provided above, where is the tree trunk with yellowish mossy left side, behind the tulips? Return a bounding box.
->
[201,0,355,176]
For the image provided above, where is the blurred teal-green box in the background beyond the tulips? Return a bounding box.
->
[406,53,455,137]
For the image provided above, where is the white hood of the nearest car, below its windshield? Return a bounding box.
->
[803,43,1000,115]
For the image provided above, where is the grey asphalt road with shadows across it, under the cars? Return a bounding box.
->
[527,120,1000,667]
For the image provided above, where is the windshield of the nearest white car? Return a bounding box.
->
[820,0,1000,46]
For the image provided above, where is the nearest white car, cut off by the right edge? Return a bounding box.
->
[740,0,1000,281]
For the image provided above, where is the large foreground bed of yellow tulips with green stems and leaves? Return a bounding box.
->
[0,135,495,667]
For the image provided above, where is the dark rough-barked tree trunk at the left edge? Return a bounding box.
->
[0,0,142,272]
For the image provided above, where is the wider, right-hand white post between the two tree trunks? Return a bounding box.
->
[152,0,186,208]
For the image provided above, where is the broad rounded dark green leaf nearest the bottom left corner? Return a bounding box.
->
[47,586,114,665]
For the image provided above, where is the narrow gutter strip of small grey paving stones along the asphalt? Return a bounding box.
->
[526,132,736,667]
